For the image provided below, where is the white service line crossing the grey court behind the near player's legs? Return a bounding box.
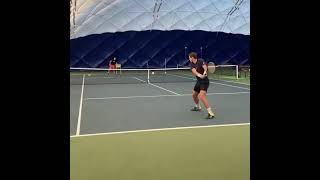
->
[84,92,250,100]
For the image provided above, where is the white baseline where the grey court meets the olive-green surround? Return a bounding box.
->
[70,123,250,138]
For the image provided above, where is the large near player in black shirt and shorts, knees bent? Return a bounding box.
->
[189,52,214,119]
